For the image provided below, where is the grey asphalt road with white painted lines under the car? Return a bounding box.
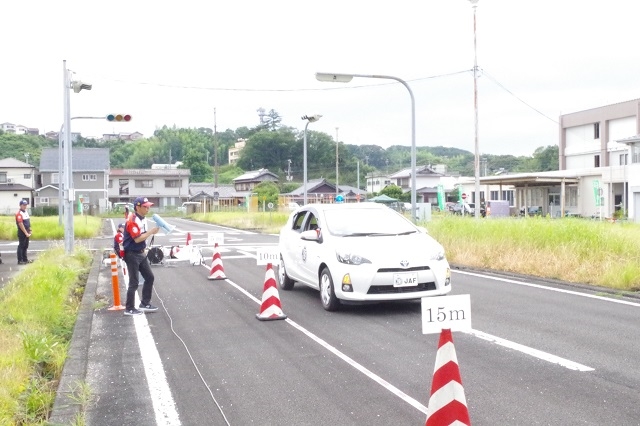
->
[38,219,640,426]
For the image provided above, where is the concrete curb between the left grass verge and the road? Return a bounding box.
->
[48,250,102,426]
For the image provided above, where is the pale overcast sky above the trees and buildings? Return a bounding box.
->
[0,0,640,155]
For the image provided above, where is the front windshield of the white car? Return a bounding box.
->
[324,209,418,236]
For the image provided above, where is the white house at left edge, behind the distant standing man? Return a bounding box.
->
[0,158,35,214]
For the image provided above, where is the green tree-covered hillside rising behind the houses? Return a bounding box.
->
[0,110,558,188]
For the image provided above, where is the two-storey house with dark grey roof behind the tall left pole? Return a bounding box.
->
[34,148,109,214]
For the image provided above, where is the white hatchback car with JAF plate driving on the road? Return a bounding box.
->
[278,203,451,311]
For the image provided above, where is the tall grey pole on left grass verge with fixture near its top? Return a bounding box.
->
[58,60,91,254]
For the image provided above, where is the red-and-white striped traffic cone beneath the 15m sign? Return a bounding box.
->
[426,328,471,426]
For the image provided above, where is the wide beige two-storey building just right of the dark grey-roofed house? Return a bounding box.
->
[107,168,191,210]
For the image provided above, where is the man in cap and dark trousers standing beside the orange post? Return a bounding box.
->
[123,197,160,315]
